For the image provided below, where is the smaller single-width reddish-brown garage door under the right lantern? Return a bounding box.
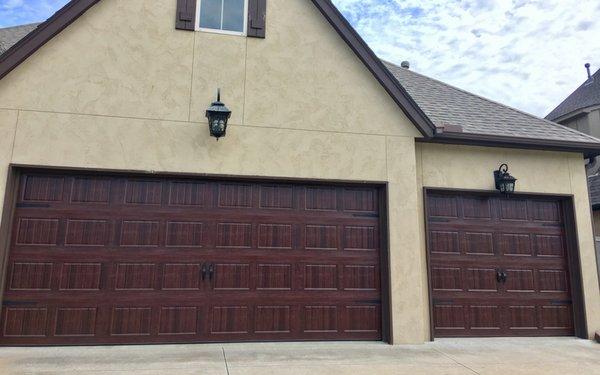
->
[427,193,574,337]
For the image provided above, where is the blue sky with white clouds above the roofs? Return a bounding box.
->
[0,0,600,117]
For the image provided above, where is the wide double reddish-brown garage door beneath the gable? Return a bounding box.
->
[0,172,382,345]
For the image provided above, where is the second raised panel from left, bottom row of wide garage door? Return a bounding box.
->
[54,307,97,336]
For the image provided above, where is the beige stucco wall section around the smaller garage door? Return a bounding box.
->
[417,144,600,338]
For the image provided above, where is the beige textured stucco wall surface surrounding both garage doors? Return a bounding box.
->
[0,0,600,344]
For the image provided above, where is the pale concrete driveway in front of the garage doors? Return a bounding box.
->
[0,338,600,375]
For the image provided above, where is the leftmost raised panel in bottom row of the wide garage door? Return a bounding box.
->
[3,307,48,337]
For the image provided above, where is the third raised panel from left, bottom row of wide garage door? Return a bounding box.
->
[110,307,152,336]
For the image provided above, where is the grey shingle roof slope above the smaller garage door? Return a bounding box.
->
[384,61,600,143]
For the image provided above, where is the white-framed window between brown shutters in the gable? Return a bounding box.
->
[198,0,248,34]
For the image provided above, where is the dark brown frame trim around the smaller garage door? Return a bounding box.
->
[423,187,588,341]
